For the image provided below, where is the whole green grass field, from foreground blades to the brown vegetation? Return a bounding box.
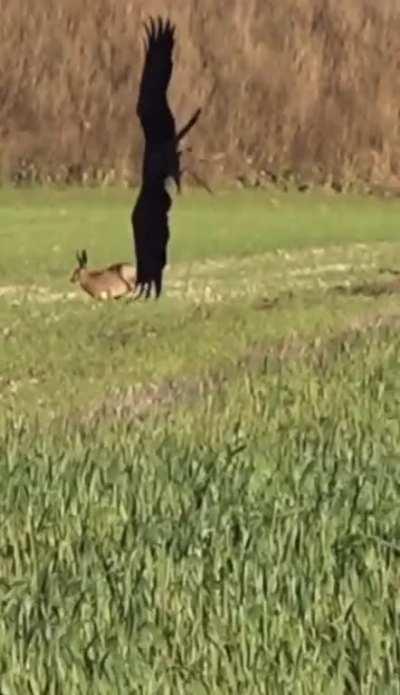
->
[0,189,400,695]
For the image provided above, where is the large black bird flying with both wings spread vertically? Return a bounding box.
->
[131,18,201,299]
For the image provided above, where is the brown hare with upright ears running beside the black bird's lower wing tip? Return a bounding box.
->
[70,250,135,299]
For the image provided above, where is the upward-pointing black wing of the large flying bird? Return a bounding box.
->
[136,18,176,145]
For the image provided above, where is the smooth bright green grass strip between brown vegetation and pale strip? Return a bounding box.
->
[0,189,400,286]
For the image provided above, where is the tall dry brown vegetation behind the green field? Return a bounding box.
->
[0,0,400,188]
